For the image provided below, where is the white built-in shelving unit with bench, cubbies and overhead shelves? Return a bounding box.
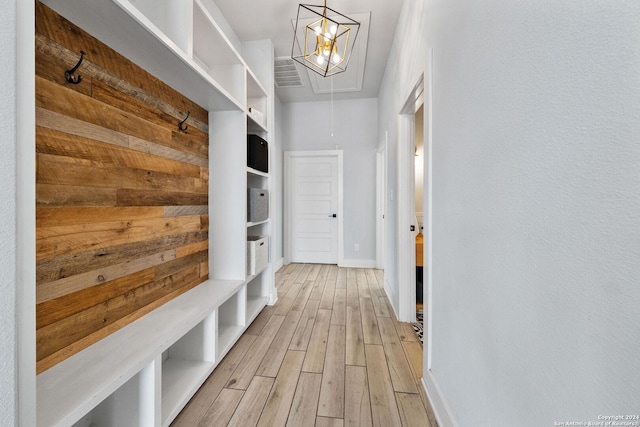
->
[36,0,277,427]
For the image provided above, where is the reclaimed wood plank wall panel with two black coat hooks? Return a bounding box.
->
[35,3,209,373]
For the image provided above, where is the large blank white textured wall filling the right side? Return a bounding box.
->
[379,0,640,426]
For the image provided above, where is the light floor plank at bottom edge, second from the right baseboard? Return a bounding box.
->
[365,345,401,427]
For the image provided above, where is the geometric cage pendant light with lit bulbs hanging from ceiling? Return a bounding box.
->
[291,0,360,77]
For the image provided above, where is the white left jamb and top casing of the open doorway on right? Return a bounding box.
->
[398,76,424,322]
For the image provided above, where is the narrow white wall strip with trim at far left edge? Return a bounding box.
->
[0,1,36,426]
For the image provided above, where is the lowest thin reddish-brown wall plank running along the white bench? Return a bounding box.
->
[36,278,202,374]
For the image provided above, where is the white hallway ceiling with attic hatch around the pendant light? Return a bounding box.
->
[214,0,403,102]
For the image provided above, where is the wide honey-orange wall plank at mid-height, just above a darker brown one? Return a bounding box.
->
[36,216,208,260]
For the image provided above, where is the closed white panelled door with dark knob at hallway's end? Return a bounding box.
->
[287,152,342,264]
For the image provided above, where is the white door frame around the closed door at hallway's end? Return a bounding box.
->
[284,150,344,265]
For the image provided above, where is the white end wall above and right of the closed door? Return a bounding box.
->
[282,99,378,266]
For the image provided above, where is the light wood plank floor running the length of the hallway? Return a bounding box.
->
[172,264,437,427]
